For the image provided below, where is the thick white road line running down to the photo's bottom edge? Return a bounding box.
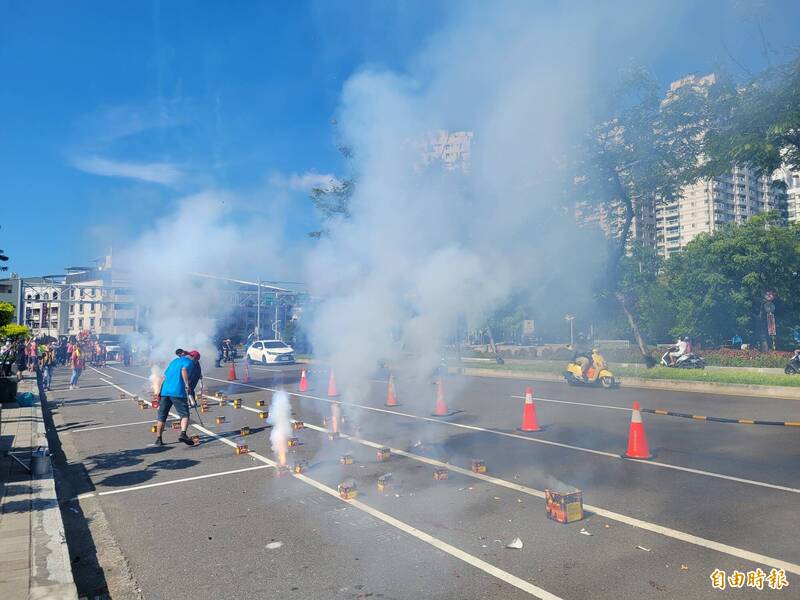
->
[95,367,562,600]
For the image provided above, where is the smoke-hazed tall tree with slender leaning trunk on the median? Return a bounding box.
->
[570,70,707,361]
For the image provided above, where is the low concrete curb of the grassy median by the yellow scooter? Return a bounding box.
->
[447,367,800,400]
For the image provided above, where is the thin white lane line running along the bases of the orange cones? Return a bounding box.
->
[189,375,800,494]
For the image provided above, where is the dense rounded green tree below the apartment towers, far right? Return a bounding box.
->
[664,213,800,347]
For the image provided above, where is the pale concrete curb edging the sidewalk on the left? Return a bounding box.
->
[18,380,78,600]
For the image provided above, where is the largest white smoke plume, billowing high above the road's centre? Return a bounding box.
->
[308,5,608,399]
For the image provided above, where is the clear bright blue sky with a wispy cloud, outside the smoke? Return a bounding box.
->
[0,0,800,276]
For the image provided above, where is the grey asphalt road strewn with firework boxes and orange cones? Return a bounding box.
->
[43,365,800,599]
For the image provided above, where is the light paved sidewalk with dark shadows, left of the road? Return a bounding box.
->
[0,379,78,600]
